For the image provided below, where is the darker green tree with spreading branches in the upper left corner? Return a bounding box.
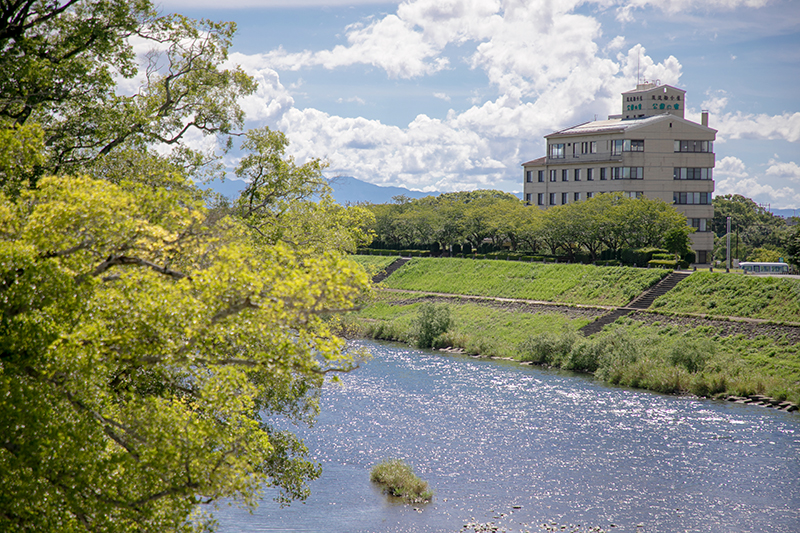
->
[0,0,255,178]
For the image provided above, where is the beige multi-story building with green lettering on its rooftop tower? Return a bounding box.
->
[522,83,717,263]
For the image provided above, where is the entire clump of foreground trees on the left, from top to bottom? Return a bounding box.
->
[0,0,372,532]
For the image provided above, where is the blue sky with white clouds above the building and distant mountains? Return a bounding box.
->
[156,0,800,214]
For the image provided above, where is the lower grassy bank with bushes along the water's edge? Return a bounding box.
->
[345,291,800,408]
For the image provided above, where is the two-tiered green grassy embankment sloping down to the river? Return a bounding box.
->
[350,259,800,403]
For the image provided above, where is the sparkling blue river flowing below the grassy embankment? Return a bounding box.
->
[217,342,800,533]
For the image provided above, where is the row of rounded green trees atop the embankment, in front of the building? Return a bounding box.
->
[367,191,693,261]
